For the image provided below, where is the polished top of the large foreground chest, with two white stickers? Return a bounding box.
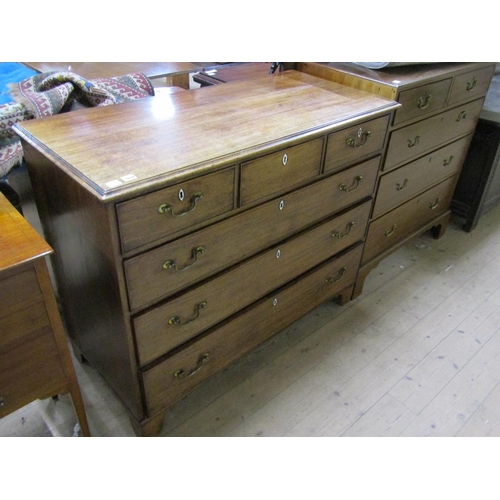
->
[14,71,399,199]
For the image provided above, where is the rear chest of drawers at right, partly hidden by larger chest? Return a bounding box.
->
[298,63,495,297]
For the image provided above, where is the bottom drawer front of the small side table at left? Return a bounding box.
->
[0,333,66,418]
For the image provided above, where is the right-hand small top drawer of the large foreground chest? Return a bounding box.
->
[324,116,389,172]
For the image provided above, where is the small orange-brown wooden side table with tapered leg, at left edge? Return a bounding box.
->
[0,193,90,436]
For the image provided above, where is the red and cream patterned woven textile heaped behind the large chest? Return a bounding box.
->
[0,71,155,177]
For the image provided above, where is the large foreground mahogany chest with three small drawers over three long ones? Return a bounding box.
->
[13,71,398,435]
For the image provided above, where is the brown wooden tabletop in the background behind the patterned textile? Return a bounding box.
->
[23,62,218,80]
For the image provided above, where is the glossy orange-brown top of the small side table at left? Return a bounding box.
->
[0,193,52,272]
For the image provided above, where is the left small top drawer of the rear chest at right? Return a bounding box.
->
[394,78,451,125]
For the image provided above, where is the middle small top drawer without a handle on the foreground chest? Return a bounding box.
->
[240,138,323,206]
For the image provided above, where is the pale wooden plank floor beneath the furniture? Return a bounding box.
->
[0,203,500,437]
